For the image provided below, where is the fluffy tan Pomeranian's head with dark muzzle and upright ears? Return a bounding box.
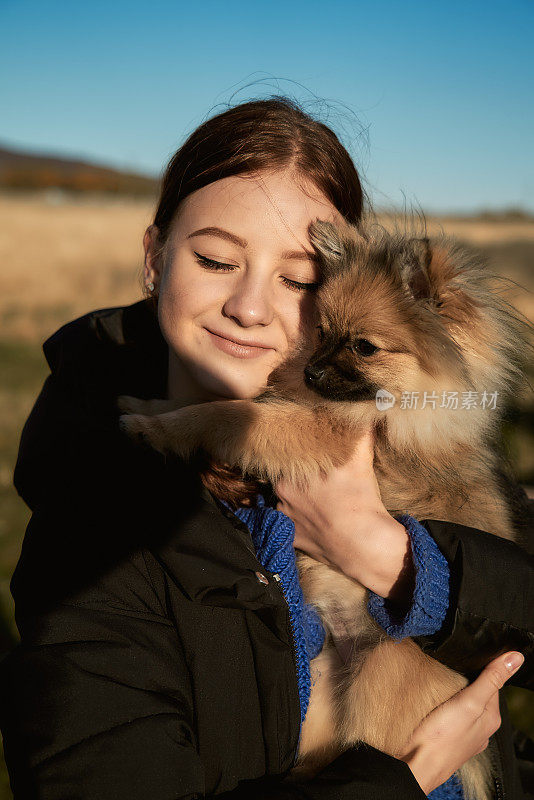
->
[304,223,482,402]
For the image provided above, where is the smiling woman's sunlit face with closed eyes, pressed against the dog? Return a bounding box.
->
[145,170,340,402]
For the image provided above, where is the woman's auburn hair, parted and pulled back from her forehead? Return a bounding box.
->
[145,96,364,505]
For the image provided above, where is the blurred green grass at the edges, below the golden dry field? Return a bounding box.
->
[0,334,534,800]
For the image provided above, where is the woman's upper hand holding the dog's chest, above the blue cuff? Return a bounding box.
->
[275,431,414,606]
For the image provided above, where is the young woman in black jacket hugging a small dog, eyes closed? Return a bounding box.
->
[0,98,534,800]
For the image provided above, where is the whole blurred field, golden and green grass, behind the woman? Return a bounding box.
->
[0,193,534,800]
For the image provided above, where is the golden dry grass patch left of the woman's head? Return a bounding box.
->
[0,196,152,341]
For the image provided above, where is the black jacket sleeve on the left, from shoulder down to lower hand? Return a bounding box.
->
[0,368,425,800]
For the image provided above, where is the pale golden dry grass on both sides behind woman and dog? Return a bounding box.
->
[0,194,534,342]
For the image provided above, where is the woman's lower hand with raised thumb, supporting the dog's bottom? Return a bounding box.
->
[400,651,524,794]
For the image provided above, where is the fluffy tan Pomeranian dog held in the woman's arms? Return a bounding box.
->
[119,222,529,800]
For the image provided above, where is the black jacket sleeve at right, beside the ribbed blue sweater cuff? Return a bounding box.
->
[415,490,534,689]
